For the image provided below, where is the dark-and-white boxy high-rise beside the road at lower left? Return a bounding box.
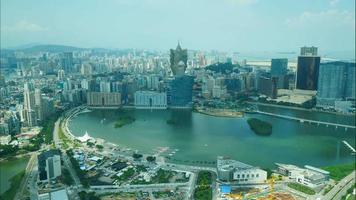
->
[37,149,62,181]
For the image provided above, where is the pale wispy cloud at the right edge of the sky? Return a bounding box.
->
[285,10,355,28]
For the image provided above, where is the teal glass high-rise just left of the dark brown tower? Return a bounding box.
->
[271,58,288,89]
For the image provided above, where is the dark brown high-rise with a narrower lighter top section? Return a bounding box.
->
[296,47,320,90]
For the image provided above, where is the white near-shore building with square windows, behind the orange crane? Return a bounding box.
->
[217,156,267,184]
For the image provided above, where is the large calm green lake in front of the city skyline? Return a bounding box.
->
[69,108,355,167]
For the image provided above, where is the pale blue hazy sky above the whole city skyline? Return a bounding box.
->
[0,0,355,51]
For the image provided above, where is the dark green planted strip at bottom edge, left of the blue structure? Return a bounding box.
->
[194,171,213,200]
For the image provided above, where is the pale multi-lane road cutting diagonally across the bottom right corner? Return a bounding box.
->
[322,171,355,200]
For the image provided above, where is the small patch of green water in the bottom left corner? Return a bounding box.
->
[0,157,29,194]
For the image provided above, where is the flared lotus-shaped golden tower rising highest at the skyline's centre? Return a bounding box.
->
[170,43,188,76]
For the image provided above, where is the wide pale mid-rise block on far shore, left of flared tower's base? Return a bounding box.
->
[135,91,167,109]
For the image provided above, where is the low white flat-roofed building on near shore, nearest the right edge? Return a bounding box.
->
[276,163,330,188]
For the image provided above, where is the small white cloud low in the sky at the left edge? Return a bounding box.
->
[1,20,49,32]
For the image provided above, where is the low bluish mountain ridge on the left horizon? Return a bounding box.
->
[19,44,85,53]
